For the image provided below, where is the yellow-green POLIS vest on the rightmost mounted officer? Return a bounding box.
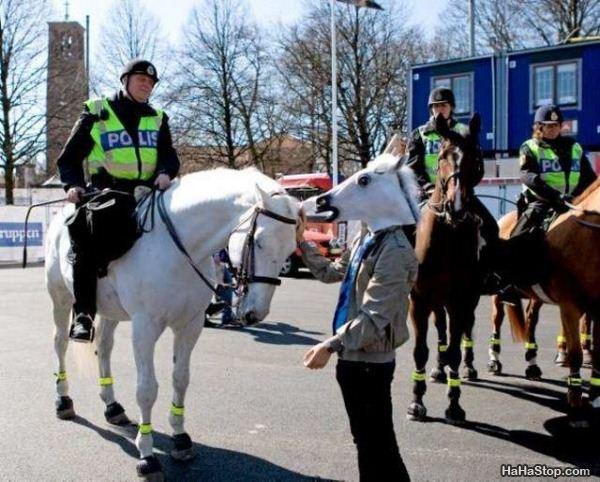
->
[525,139,583,194]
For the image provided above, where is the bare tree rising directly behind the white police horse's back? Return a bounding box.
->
[175,0,277,169]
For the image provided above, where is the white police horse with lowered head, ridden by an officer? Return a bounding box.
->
[46,169,299,479]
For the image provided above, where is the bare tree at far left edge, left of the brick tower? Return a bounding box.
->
[0,0,49,204]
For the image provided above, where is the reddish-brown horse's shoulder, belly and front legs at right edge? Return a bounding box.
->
[496,179,600,427]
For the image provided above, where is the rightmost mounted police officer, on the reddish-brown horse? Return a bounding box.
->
[511,105,596,237]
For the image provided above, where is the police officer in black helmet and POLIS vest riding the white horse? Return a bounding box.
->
[57,59,179,342]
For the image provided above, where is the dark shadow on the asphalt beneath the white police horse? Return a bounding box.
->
[73,416,341,482]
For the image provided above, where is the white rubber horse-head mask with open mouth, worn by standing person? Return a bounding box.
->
[305,153,419,231]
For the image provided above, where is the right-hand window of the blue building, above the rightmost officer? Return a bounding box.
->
[533,62,579,109]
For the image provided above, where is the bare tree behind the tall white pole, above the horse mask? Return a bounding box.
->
[280,1,424,170]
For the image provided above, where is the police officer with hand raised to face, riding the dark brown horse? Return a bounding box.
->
[406,87,499,292]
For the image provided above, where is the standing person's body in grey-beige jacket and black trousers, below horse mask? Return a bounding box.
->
[296,212,418,482]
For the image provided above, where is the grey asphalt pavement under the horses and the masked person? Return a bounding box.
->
[0,267,600,481]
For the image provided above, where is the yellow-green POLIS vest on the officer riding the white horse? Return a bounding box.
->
[86,99,163,181]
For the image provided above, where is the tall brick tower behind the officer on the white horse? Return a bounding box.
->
[46,21,88,176]
